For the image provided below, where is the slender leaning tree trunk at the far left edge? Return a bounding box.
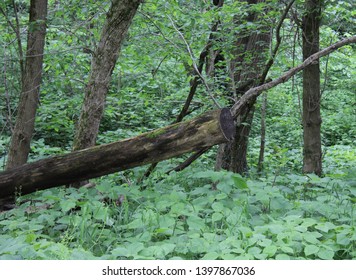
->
[6,0,47,169]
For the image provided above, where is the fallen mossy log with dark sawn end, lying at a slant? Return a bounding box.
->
[0,108,235,198]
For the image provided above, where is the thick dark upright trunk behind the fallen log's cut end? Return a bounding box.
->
[215,0,270,174]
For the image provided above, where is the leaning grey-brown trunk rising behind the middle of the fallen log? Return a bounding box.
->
[73,0,142,150]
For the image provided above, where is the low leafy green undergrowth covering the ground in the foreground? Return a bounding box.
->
[0,167,356,259]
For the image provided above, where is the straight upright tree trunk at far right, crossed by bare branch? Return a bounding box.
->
[303,0,322,175]
